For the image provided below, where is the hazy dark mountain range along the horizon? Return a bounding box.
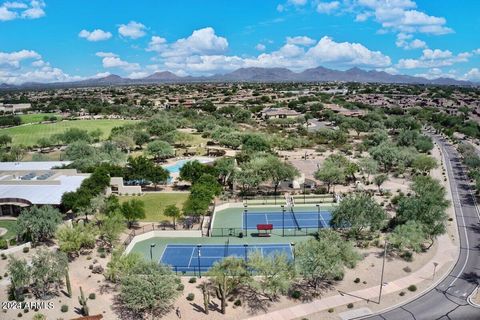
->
[0,67,479,90]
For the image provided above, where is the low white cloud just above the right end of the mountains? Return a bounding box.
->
[397,49,472,69]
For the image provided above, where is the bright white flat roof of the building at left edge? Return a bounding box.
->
[0,175,88,205]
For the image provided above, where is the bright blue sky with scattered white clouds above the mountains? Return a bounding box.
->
[0,0,480,83]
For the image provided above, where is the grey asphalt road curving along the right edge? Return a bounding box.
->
[366,135,480,320]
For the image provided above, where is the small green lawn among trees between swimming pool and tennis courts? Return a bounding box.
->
[119,192,189,222]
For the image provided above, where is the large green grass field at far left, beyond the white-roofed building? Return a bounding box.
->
[0,120,139,146]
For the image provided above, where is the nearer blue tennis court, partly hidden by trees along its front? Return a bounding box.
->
[160,244,293,272]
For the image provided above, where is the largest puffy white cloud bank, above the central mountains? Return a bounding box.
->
[147,28,391,75]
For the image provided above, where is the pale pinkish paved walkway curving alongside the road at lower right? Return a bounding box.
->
[249,235,457,320]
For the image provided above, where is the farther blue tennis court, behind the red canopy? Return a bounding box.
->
[243,209,332,229]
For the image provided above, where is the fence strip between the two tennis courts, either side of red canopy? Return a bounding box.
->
[210,227,321,238]
